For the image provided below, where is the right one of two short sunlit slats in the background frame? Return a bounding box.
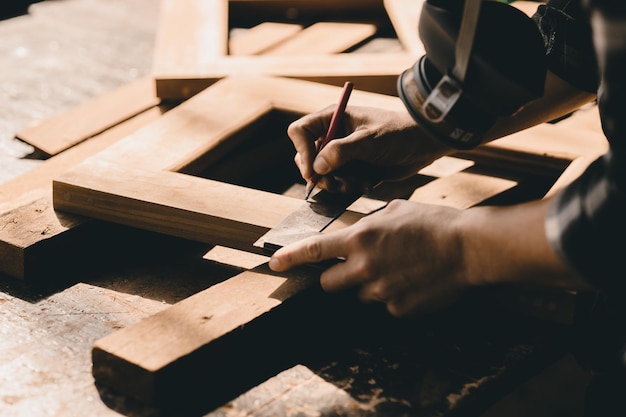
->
[263,22,377,56]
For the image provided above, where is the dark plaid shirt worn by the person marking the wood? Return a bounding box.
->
[533,0,626,296]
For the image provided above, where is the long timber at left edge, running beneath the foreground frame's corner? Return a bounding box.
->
[0,107,162,280]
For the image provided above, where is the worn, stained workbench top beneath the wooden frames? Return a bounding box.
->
[0,0,588,417]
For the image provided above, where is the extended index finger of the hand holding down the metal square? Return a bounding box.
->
[269,231,346,271]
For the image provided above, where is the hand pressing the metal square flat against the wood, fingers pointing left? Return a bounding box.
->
[269,200,469,317]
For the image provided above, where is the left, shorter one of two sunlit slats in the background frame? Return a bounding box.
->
[228,22,302,55]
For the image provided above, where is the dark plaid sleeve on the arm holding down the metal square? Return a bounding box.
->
[546,1,626,297]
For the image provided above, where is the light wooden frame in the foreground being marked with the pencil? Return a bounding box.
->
[47,76,605,405]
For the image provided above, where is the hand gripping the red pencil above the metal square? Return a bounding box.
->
[287,106,450,192]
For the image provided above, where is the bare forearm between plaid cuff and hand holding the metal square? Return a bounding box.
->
[455,199,589,289]
